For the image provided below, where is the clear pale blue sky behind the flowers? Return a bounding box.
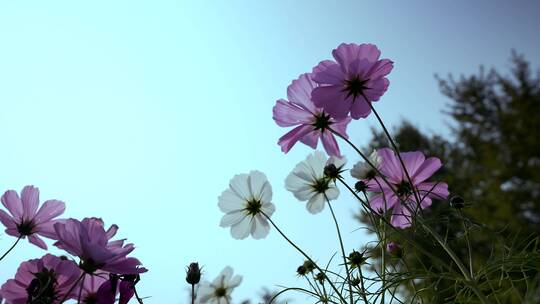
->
[0,0,540,303]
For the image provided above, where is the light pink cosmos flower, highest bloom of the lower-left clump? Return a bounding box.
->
[0,186,65,249]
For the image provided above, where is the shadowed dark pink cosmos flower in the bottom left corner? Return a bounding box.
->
[0,254,82,304]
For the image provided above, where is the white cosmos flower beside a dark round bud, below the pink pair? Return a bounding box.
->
[285,151,345,214]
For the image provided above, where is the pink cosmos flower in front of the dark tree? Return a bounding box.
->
[367,148,448,228]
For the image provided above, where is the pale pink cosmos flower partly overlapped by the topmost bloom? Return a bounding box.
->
[273,74,351,156]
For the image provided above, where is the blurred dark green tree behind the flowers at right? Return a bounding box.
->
[359,53,540,303]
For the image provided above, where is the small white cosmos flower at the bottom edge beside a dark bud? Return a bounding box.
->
[197,266,242,304]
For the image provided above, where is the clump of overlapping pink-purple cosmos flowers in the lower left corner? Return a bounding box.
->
[0,186,147,304]
